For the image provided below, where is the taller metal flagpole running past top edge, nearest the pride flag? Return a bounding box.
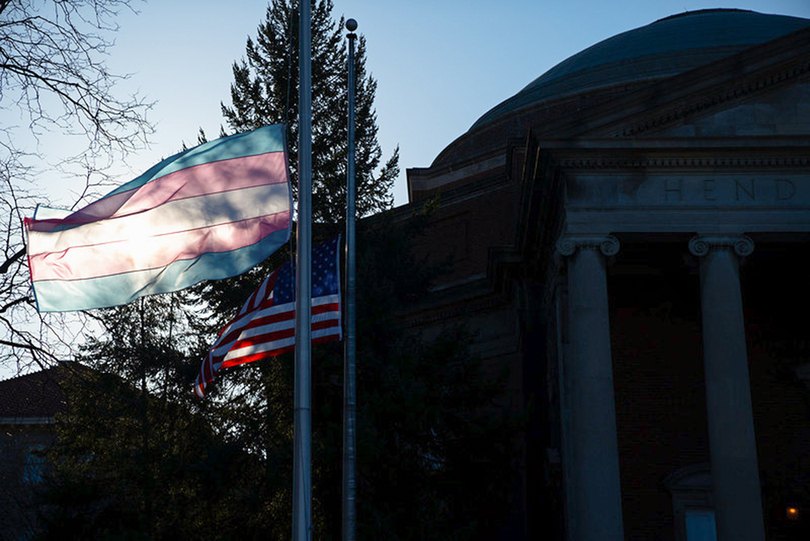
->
[292,0,312,541]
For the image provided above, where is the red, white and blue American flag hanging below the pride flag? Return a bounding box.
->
[194,237,342,398]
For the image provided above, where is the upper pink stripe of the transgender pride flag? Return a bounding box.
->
[26,152,287,232]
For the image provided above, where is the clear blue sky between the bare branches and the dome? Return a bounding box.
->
[42,0,810,205]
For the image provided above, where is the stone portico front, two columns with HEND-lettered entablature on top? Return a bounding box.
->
[535,135,810,541]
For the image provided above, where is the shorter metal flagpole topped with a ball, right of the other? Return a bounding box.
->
[343,19,357,541]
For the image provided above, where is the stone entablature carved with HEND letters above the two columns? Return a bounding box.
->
[538,138,810,234]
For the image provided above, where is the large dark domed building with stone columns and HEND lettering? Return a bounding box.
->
[394,9,810,541]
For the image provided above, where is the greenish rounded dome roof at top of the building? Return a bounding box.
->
[470,9,810,131]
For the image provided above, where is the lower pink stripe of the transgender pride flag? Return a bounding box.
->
[29,211,290,281]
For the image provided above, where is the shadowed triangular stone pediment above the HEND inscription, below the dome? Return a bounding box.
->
[560,28,810,138]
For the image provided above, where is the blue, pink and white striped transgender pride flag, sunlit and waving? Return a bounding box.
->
[25,125,292,312]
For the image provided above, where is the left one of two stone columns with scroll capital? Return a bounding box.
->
[557,236,624,541]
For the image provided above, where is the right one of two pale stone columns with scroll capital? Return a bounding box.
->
[689,236,765,541]
